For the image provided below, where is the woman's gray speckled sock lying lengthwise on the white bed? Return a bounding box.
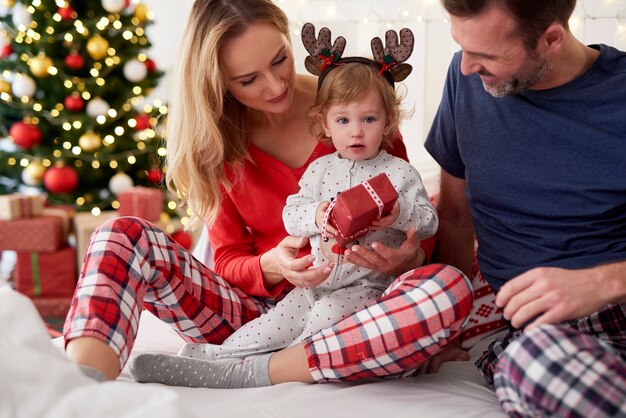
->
[130,353,272,389]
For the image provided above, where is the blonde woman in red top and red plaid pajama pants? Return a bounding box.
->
[64,0,471,383]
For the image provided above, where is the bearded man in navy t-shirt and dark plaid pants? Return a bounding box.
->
[426,0,626,417]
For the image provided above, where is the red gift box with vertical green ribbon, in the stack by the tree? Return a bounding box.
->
[14,246,76,299]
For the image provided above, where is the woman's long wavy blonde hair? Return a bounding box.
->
[166,0,289,226]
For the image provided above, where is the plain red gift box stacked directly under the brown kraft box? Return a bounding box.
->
[0,216,67,252]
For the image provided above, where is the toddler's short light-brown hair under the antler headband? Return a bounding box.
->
[307,62,404,148]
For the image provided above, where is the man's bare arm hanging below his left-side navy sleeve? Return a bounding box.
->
[433,169,474,277]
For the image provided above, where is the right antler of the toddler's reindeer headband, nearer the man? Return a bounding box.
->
[371,28,415,81]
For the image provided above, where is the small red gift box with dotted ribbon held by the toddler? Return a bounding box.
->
[329,173,398,247]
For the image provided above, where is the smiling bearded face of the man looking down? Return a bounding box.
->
[451,7,551,97]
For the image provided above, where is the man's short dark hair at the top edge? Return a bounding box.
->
[441,0,576,49]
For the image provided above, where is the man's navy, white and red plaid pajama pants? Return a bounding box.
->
[476,304,626,418]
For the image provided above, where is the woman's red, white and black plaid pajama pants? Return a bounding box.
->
[64,217,472,382]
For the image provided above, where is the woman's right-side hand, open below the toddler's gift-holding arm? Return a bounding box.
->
[343,227,426,277]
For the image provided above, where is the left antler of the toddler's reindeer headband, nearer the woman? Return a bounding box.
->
[302,23,346,75]
